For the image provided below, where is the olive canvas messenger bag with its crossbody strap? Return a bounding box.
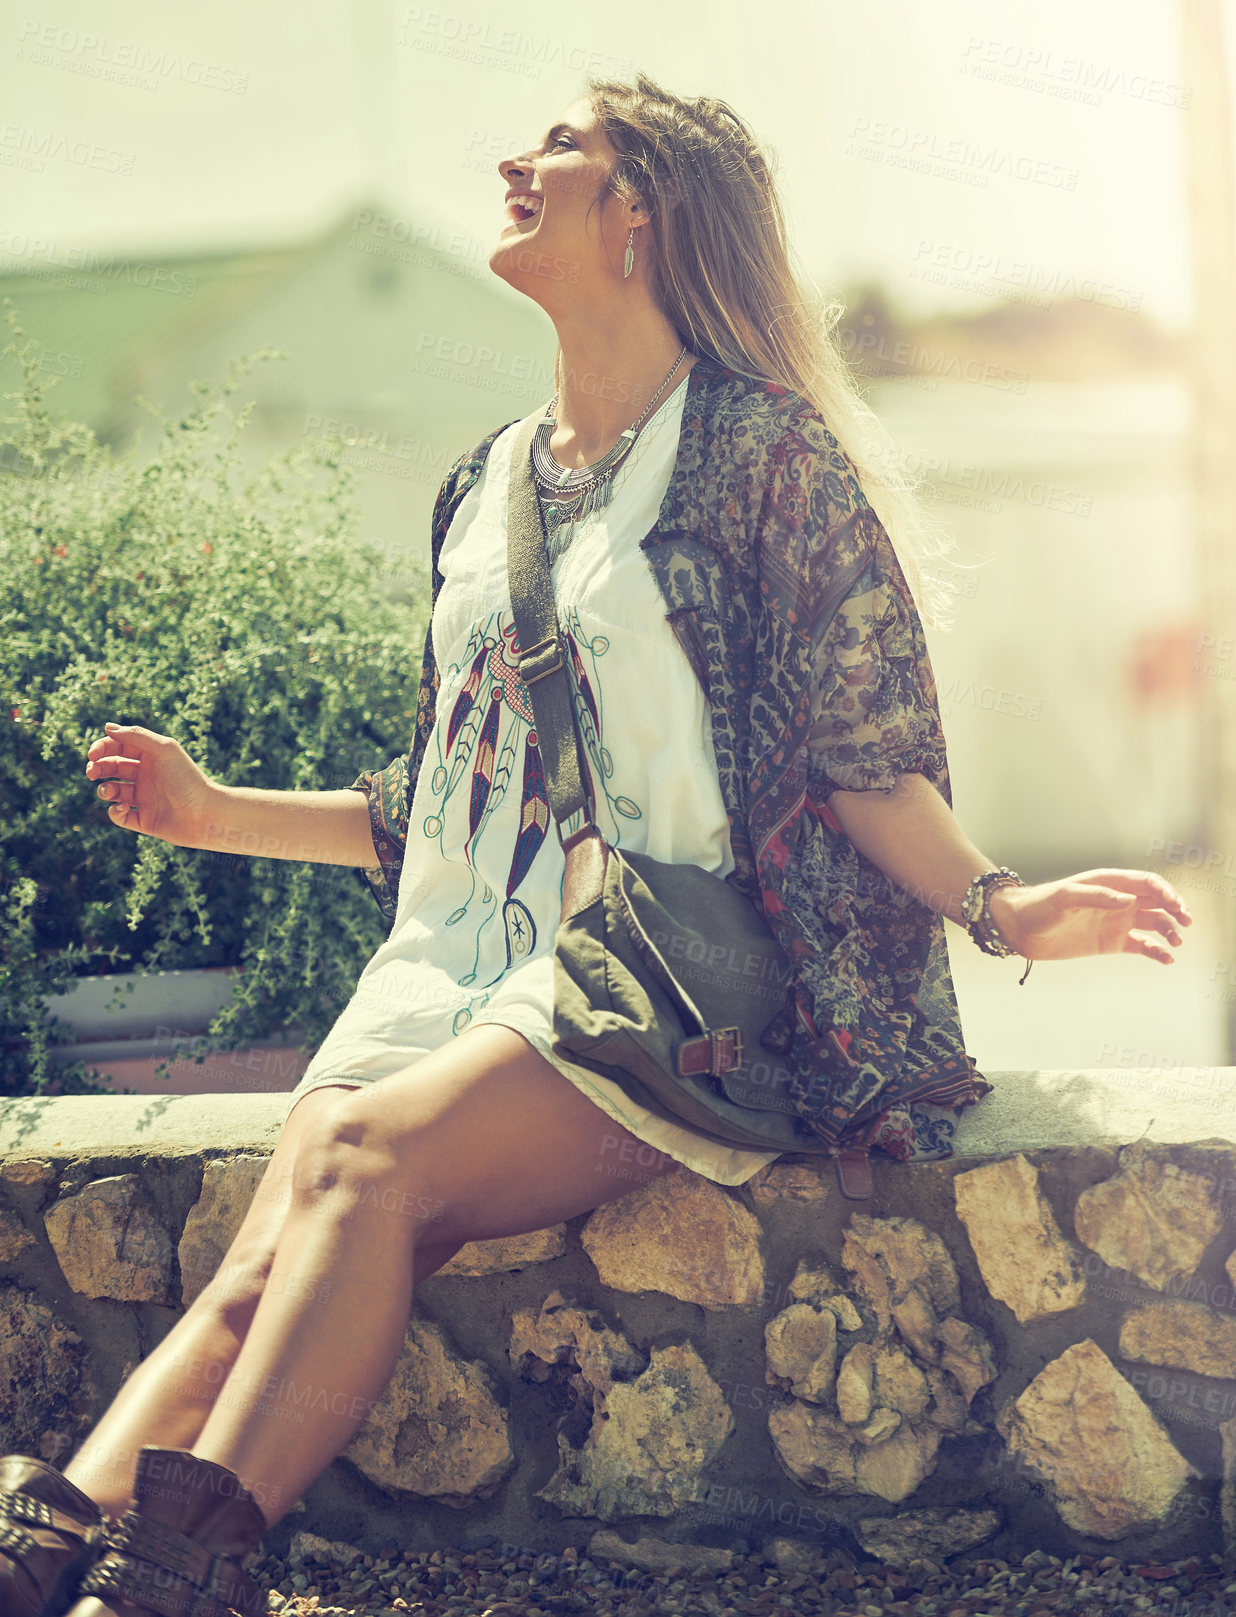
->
[506,417,870,1200]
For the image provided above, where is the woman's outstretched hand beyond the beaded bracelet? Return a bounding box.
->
[990,870,1192,965]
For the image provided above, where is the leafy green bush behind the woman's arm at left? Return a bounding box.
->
[0,299,429,1095]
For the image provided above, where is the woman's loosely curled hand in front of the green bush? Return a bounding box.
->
[86,721,223,847]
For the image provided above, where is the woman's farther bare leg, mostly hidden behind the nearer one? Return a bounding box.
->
[63,1085,469,1515]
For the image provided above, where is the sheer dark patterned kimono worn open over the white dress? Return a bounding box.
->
[344,357,992,1182]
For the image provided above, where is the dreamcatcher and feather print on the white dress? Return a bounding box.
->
[422,611,641,1033]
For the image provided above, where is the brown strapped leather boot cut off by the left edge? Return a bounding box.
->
[0,1454,108,1617]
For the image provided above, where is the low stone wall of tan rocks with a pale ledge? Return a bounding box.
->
[0,1069,1236,1562]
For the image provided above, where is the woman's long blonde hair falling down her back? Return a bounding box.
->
[569,73,956,629]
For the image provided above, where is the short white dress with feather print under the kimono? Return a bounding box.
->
[288,378,780,1185]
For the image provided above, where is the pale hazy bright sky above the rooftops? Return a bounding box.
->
[0,0,1236,328]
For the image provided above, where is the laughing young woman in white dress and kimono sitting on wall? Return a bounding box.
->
[0,74,1191,1617]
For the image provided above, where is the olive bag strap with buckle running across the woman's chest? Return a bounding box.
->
[506,416,600,851]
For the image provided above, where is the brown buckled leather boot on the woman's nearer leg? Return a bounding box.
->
[60,1446,267,1617]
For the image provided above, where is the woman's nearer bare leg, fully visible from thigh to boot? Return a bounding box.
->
[193,1024,681,1525]
